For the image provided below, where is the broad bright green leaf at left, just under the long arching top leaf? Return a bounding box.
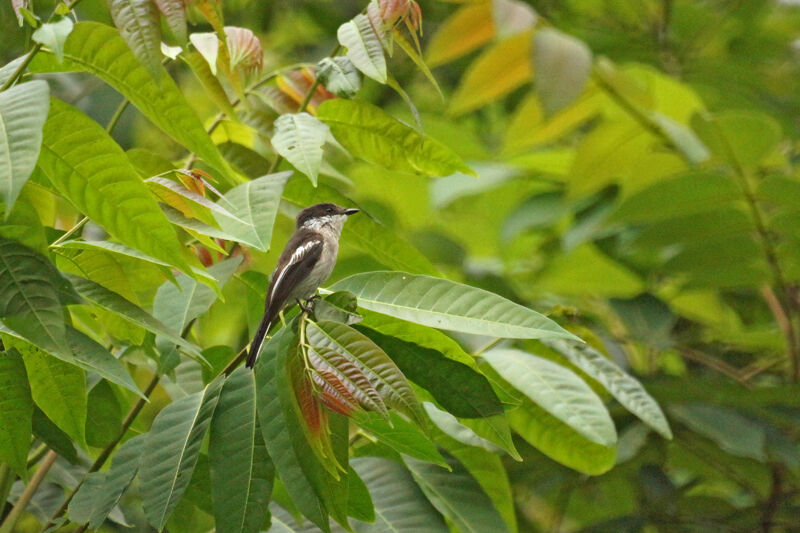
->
[39,99,198,272]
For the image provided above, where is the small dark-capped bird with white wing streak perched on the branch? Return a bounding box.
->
[246,203,358,368]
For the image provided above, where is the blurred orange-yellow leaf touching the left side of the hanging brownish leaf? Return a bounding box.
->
[448,31,533,115]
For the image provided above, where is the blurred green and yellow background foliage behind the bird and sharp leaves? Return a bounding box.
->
[0,0,800,532]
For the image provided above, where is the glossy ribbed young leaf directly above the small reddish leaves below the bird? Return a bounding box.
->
[306,320,424,423]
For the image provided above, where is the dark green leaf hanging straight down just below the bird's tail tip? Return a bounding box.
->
[208,367,274,533]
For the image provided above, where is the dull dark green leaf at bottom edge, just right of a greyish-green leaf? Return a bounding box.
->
[404,457,508,533]
